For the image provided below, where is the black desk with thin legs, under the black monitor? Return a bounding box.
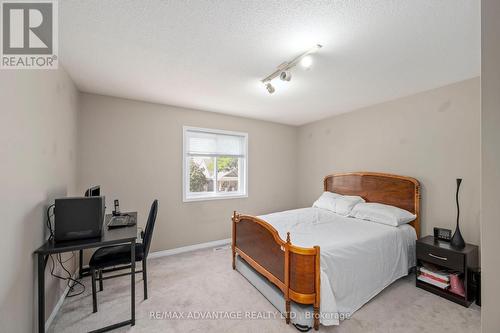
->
[35,212,137,333]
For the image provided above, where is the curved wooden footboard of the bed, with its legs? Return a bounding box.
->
[232,212,320,330]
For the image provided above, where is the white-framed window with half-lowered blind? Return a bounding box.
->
[183,127,248,202]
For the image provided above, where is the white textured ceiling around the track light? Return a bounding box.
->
[59,0,480,125]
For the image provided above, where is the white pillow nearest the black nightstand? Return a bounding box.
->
[350,202,417,227]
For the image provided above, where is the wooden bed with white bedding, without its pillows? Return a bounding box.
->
[232,172,420,330]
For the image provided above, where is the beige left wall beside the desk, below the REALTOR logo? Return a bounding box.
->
[0,69,78,333]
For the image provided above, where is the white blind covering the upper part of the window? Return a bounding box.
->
[186,130,245,157]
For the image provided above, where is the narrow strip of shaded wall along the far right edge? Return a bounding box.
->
[481,0,500,333]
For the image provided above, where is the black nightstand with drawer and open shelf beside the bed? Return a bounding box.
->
[416,236,479,307]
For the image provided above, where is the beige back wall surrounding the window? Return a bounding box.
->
[78,94,297,251]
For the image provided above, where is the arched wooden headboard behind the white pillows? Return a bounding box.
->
[324,172,420,237]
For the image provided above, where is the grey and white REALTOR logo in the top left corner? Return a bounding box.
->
[0,0,58,69]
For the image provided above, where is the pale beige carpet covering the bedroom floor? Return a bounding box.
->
[50,248,480,333]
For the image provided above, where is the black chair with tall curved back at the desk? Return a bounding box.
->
[89,200,158,312]
